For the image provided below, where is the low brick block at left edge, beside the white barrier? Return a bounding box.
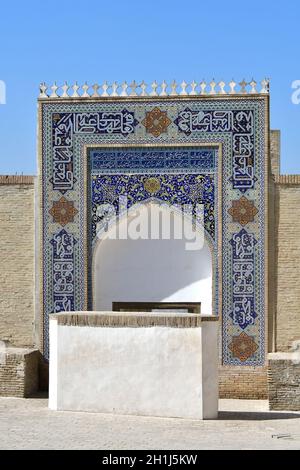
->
[0,348,39,398]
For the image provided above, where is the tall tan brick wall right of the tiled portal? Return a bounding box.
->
[275,175,300,351]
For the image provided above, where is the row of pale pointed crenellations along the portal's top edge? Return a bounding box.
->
[39,78,270,99]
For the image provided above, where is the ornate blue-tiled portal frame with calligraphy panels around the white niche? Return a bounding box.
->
[39,82,268,365]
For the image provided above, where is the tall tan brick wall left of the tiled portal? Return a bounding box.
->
[0,176,34,346]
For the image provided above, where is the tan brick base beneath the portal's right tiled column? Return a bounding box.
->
[219,366,268,400]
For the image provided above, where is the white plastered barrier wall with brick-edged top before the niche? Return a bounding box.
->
[49,312,218,419]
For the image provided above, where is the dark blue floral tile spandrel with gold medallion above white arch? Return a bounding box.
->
[91,173,215,240]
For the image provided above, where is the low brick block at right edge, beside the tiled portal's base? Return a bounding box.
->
[268,359,300,411]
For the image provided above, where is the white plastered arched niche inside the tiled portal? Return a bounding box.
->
[92,201,213,315]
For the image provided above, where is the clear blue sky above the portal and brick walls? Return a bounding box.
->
[0,0,300,174]
